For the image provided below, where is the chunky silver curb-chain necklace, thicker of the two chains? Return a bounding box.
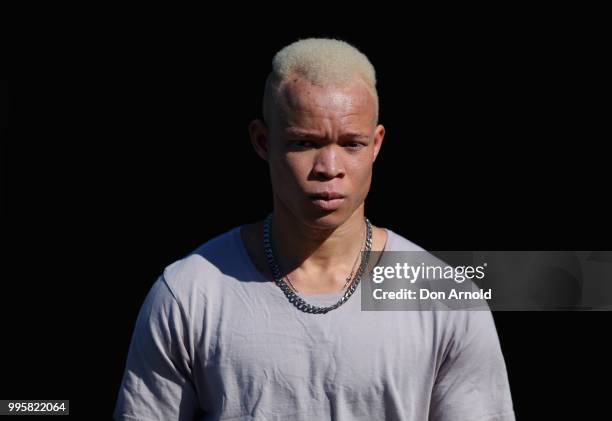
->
[263,214,372,314]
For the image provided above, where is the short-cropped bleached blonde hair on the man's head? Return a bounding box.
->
[263,38,378,122]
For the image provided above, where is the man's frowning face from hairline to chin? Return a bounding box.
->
[260,78,384,228]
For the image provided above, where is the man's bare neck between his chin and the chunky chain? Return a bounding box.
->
[271,204,366,274]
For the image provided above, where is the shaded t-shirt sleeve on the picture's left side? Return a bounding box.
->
[114,276,198,421]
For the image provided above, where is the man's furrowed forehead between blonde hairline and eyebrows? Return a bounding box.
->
[277,78,375,127]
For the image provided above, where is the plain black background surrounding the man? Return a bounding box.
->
[0,12,612,420]
